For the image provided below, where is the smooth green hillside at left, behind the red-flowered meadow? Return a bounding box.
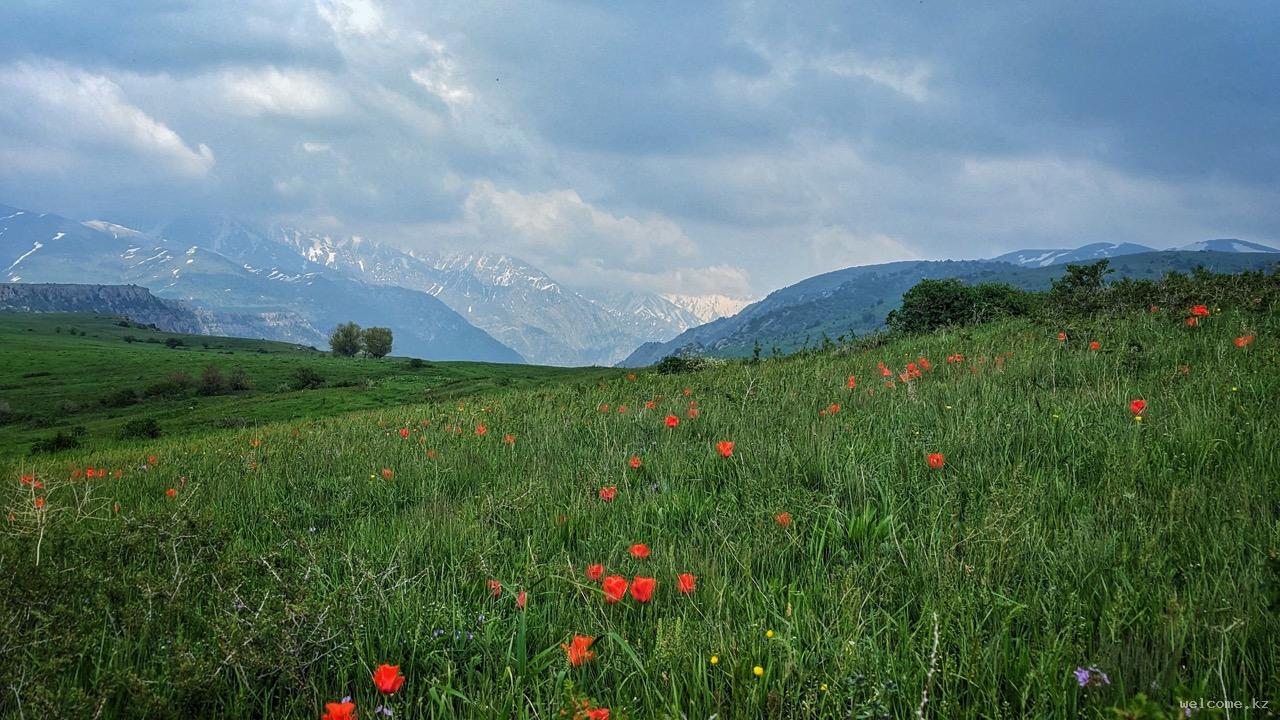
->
[0,313,602,455]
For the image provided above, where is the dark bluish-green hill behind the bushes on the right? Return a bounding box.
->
[620,251,1275,368]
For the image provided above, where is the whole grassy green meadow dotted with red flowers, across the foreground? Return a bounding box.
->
[0,309,1280,719]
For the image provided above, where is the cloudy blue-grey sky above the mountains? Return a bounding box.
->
[0,0,1280,296]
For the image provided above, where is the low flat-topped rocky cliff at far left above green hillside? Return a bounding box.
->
[0,283,206,333]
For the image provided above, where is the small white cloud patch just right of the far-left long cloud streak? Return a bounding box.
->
[218,67,348,119]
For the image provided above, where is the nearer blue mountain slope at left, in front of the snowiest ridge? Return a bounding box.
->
[0,209,524,363]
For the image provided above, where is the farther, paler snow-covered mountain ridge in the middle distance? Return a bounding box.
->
[273,228,699,365]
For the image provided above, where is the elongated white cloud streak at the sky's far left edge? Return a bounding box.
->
[0,63,215,177]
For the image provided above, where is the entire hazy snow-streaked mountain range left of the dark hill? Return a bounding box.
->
[0,205,735,365]
